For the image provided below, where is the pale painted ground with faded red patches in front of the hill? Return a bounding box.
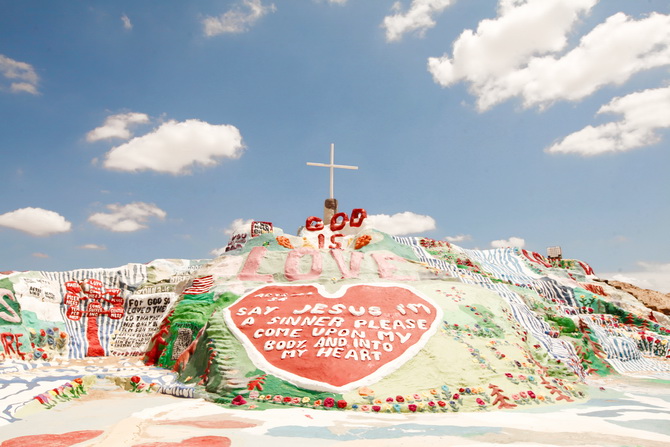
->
[0,360,670,447]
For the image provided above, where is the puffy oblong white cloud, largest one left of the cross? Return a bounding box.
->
[104,120,244,174]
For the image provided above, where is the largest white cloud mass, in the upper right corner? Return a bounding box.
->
[428,0,670,110]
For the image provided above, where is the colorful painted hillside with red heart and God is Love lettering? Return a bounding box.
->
[0,209,670,413]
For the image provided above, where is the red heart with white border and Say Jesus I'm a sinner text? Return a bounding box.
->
[224,284,441,393]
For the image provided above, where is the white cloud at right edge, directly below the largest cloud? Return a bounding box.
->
[547,87,670,156]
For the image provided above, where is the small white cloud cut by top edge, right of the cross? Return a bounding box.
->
[382,0,455,42]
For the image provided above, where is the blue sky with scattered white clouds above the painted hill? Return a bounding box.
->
[0,0,670,291]
